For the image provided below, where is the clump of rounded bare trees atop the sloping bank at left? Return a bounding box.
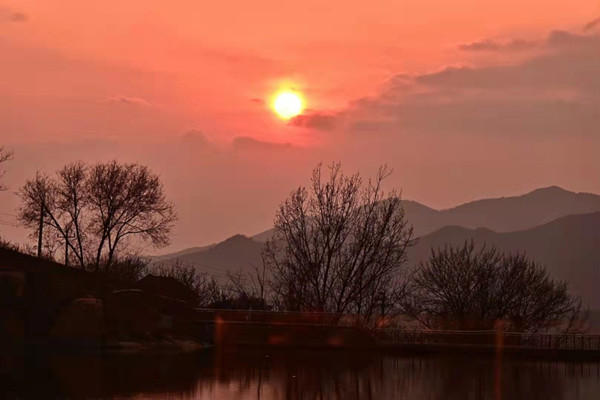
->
[19,161,176,272]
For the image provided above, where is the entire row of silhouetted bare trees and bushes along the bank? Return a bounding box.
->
[0,152,585,332]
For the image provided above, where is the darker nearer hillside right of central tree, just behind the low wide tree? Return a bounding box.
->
[409,213,600,309]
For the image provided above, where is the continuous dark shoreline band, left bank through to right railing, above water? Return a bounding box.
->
[0,249,600,360]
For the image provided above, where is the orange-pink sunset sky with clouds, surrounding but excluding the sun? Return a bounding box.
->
[0,0,600,249]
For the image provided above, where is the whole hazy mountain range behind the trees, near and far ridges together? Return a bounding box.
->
[159,186,600,309]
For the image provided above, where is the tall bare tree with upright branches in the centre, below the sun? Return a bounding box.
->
[263,163,414,315]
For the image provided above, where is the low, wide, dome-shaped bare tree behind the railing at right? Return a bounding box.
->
[403,241,584,332]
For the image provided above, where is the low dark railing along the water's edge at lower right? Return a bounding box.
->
[373,329,600,351]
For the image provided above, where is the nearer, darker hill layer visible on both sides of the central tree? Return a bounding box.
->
[159,213,600,309]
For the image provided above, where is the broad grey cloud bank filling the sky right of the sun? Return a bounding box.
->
[344,27,600,138]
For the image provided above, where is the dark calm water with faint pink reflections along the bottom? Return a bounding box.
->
[0,351,600,400]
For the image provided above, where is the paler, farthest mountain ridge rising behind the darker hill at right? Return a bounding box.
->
[252,186,600,242]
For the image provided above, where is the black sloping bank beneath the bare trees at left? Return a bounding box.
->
[0,249,209,351]
